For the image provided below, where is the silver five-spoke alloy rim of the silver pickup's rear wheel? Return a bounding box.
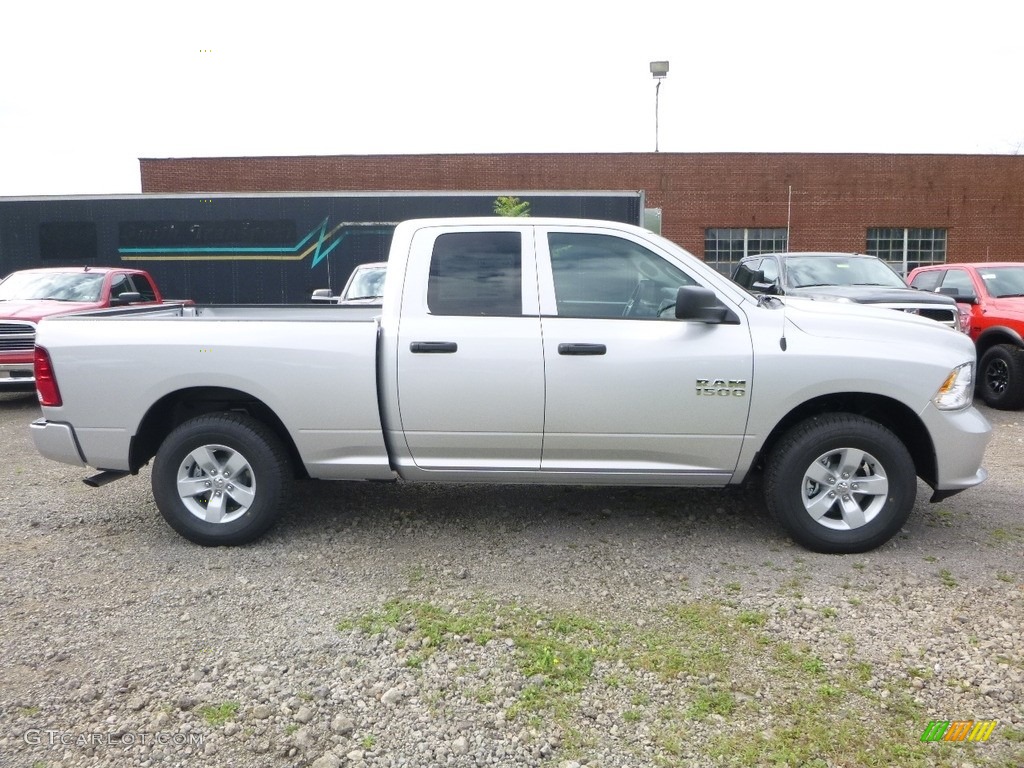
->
[177,444,256,523]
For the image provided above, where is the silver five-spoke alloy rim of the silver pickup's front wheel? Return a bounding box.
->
[802,447,889,530]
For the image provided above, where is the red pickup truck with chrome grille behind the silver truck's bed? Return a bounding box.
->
[0,266,179,392]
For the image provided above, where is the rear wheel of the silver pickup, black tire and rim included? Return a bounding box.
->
[153,414,293,547]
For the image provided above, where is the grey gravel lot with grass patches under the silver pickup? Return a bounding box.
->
[0,395,1024,768]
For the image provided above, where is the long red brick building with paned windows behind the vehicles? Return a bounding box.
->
[139,153,1024,269]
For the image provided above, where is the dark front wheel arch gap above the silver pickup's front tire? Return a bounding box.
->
[756,392,938,486]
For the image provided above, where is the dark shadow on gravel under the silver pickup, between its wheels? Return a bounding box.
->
[272,481,786,545]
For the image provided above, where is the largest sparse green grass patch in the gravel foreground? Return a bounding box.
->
[338,600,954,768]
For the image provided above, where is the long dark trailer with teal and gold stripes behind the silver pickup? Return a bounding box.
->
[0,190,644,304]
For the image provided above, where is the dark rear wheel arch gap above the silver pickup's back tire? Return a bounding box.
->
[128,387,305,476]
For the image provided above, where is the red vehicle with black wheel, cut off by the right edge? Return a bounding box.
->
[907,261,1024,410]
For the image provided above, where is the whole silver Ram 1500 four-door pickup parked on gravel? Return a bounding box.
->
[32,218,991,552]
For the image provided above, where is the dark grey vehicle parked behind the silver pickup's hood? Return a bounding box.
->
[732,253,961,331]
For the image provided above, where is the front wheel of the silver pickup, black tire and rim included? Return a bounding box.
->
[764,414,918,554]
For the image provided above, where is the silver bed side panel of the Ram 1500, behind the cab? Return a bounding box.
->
[37,305,393,479]
